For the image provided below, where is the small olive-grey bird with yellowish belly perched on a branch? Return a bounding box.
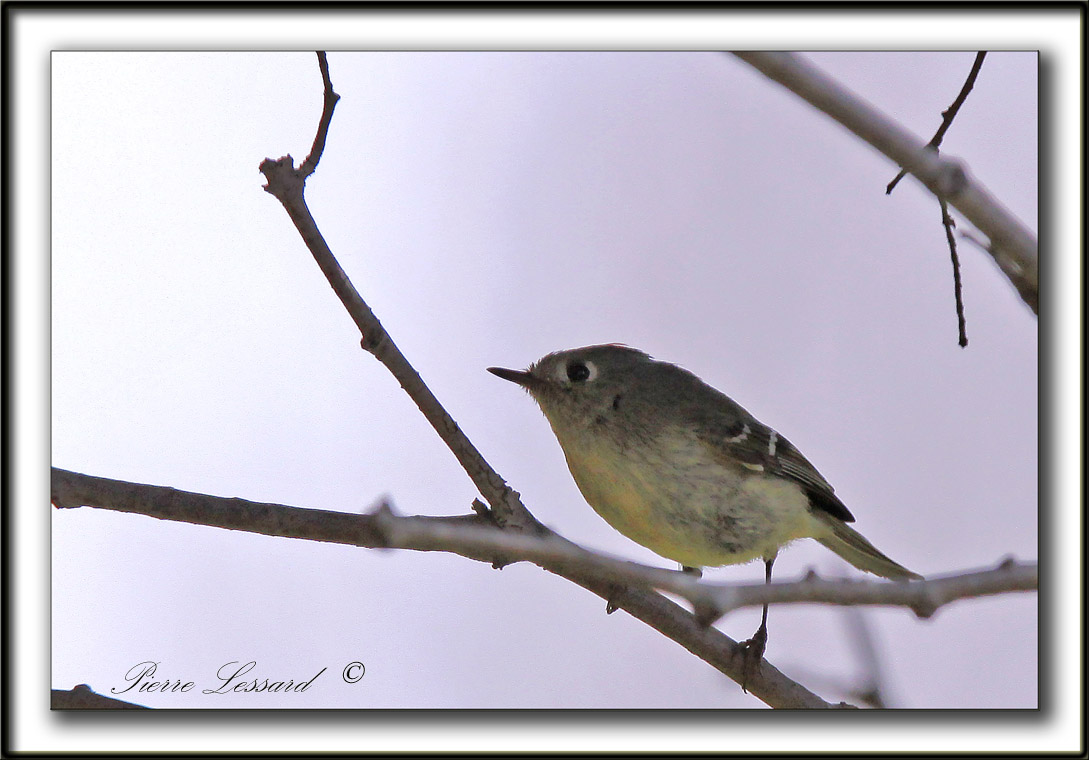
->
[488,344,922,687]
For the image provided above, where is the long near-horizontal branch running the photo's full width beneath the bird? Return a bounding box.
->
[52,467,1037,640]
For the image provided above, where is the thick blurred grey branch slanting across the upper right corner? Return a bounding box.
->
[734,52,1039,314]
